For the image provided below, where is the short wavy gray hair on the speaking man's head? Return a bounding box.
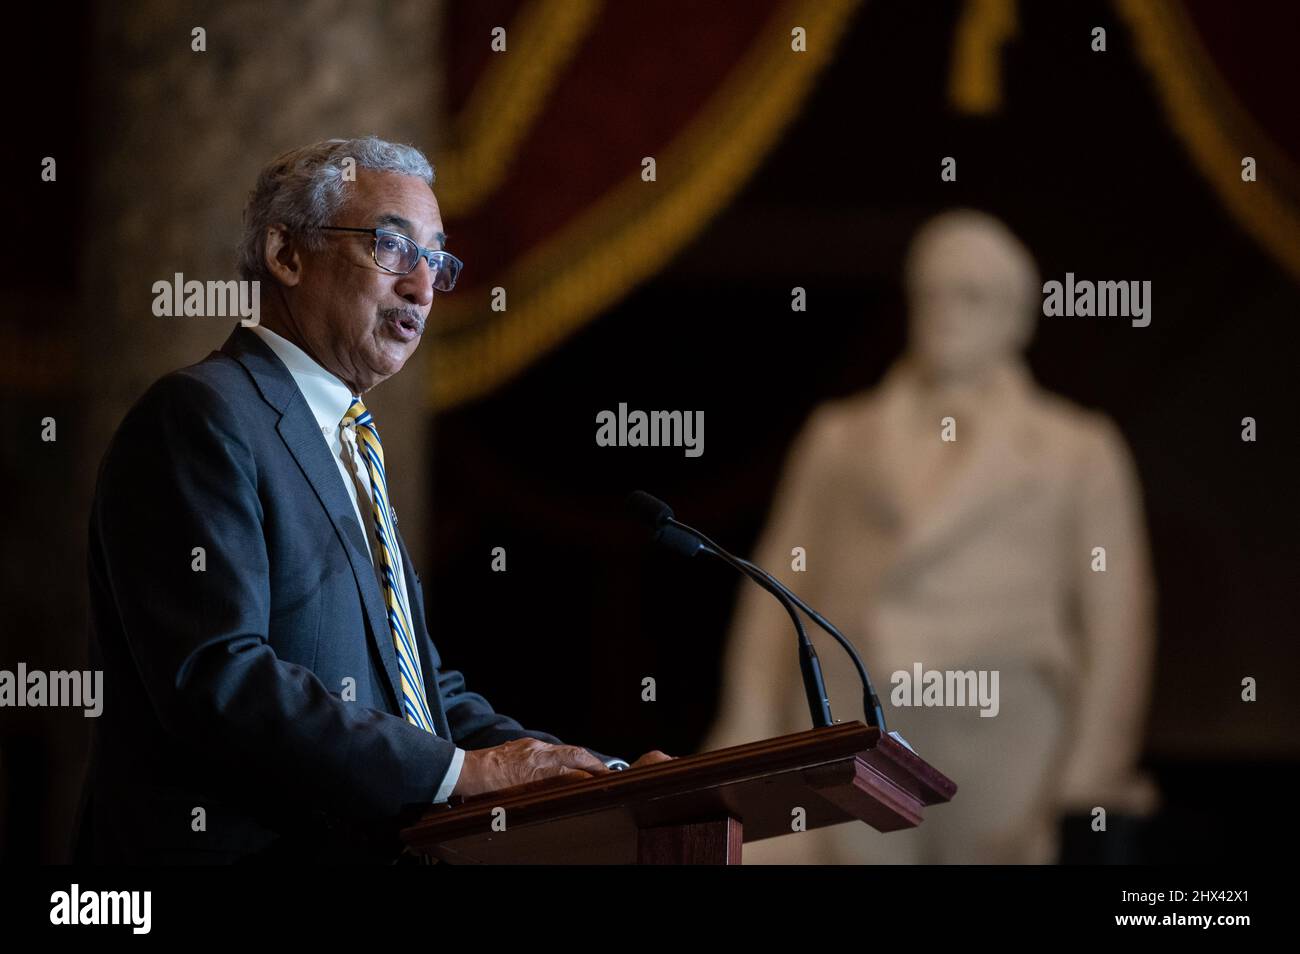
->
[238,135,434,282]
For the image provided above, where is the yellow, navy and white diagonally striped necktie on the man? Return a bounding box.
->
[342,398,434,732]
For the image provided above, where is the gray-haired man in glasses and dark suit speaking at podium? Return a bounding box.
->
[75,138,670,863]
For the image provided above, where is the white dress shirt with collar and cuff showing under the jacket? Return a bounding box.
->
[252,325,465,803]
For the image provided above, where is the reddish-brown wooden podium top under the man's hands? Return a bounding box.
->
[402,721,957,864]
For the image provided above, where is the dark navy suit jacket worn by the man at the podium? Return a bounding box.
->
[74,328,606,863]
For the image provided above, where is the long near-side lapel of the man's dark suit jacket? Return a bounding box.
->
[221,328,402,712]
